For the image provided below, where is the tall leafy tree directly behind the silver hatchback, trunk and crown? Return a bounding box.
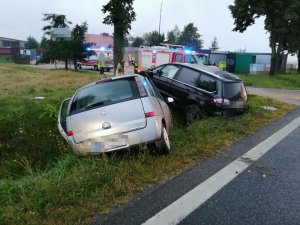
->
[102,0,136,74]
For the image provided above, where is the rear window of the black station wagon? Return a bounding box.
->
[223,82,246,101]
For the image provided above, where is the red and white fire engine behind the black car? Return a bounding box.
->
[127,45,209,73]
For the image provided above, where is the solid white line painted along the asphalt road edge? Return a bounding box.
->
[143,117,300,225]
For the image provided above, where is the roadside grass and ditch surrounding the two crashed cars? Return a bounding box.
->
[0,65,293,225]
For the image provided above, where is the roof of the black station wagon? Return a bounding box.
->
[169,63,242,81]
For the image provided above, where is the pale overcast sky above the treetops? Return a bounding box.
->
[0,0,270,52]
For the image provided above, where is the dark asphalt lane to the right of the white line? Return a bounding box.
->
[179,118,300,225]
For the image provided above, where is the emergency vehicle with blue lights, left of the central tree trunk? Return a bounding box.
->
[77,47,114,72]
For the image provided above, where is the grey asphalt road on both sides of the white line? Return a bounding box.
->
[93,105,300,225]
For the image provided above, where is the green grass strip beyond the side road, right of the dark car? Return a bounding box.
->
[239,74,300,90]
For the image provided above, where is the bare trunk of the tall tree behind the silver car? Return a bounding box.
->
[114,25,124,76]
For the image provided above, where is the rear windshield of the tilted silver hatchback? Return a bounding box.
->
[70,77,140,115]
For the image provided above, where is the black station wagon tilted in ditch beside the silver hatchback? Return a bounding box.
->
[147,63,247,122]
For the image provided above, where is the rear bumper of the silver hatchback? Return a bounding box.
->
[68,117,162,155]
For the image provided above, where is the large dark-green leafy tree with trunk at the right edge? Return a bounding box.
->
[229,0,300,75]
